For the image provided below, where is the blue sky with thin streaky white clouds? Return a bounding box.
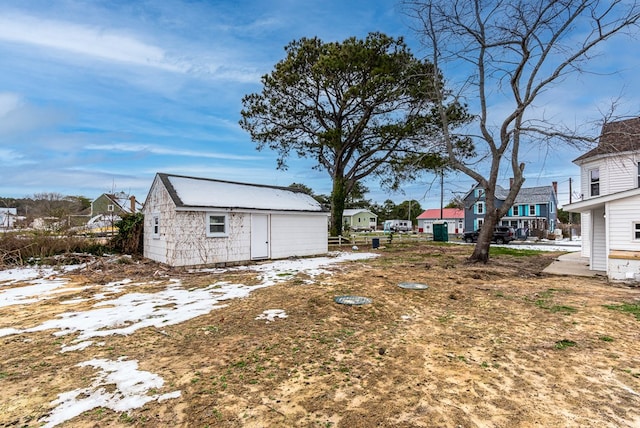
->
[0,0,640,208]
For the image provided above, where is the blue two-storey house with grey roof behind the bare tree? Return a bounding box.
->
[464,181,558,237]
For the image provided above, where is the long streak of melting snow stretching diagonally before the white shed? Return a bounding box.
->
[0,253,378,349]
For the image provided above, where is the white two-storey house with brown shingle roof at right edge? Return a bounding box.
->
[563,117,640,281]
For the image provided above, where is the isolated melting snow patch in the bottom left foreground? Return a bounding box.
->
[44,357,181,428]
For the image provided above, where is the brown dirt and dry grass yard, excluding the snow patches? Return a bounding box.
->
[0,243,640,428]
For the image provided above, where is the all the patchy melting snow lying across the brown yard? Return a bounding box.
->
[0,252,377,427]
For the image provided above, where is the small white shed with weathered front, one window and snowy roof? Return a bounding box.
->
[143,173,328,266]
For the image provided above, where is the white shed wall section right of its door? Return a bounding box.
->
[271,213,329,259]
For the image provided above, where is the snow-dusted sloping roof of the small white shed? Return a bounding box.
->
[154,173,323,212]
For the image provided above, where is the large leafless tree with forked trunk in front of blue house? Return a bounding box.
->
[403,0,640,263]
